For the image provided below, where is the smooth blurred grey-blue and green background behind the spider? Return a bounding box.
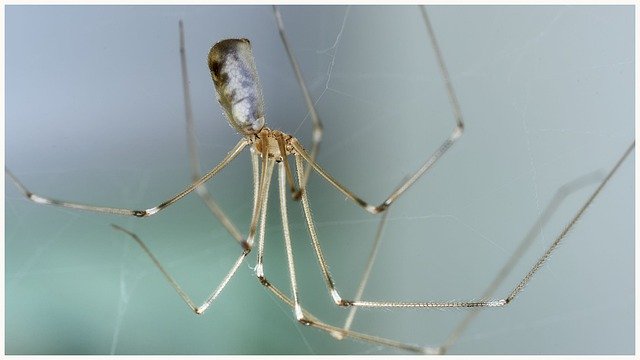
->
[5,6,635,354]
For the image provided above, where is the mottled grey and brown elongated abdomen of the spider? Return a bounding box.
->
[209,39,264,135]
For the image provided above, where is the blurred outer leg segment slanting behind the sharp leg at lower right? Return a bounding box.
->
[441,172,603,353]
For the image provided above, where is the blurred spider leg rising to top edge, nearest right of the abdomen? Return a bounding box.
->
[273,5,323,200]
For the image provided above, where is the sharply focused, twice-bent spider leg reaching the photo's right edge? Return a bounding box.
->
[296,140,635,308]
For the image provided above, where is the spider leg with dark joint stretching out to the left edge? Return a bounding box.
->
[4,139,249,217]
